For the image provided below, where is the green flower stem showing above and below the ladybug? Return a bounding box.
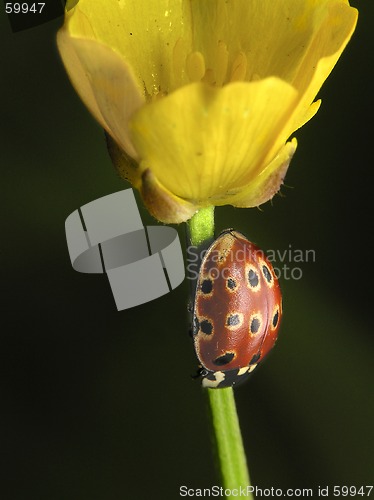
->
[188,207,253,499]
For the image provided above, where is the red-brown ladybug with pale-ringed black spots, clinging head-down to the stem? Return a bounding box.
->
[192,229,282,388]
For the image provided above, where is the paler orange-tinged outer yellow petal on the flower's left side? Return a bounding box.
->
[57,30,145,158]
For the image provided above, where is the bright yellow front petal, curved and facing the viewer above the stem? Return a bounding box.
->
[130,78,297,203]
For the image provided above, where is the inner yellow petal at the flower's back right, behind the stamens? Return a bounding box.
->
[191,0,357,85]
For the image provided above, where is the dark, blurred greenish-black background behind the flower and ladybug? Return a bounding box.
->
[0,0,374,500]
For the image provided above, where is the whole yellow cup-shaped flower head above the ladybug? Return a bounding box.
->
[58,0,357,222]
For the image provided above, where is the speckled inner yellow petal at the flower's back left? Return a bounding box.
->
[59,0,192,95]
